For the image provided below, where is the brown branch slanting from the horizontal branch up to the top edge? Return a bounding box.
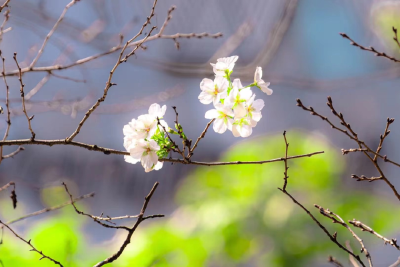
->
[65,0,157,142]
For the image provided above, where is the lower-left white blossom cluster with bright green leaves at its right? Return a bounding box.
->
[123,103,172,172]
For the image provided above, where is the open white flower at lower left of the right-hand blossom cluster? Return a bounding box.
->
[205,103,233,134]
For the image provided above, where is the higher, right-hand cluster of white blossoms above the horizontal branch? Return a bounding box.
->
[199,56,273,137]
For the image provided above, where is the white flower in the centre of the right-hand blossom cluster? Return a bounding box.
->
[225,79,253,118]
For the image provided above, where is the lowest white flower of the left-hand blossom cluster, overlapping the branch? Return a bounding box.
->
[125,140,162,172]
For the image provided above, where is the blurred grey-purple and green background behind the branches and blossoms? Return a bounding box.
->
[0,0,400,267]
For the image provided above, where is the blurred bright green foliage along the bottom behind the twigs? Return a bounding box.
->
[0,132,399,267]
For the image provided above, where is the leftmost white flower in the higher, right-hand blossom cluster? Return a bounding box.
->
[199,77,229,104]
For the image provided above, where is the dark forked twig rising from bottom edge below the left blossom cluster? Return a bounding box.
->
[94,182,164,267]
